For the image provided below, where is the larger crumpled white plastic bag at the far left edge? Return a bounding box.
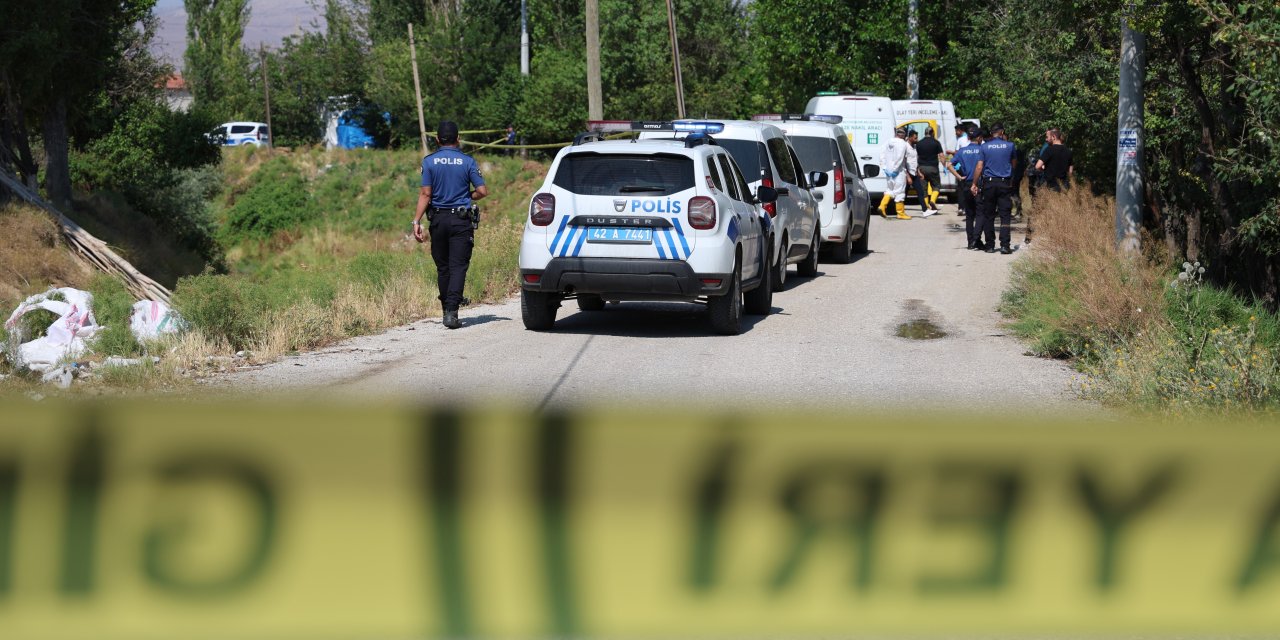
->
[4,287,101,371]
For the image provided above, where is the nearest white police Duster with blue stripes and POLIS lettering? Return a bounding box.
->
[520,120,777,334]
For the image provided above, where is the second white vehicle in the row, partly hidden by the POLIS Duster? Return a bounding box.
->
[640,120,827,291]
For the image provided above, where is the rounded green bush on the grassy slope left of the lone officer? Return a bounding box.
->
[223,157,315,242]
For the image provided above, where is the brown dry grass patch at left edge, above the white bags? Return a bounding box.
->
[0,205,93,303]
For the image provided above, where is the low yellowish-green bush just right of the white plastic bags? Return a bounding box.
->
[173,274,273,349]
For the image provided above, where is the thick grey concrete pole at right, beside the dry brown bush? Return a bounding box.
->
[1116,18,1147,251]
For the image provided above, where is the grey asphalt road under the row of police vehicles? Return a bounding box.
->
[225,199,1083,413]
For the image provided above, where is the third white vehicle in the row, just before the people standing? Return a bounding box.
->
[751,114,879,264]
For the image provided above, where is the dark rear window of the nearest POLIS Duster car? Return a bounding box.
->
[552,154,694,196]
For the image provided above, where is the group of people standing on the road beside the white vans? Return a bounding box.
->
[879,123,1074,255]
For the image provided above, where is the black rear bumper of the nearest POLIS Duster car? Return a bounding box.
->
[520,257,730,300]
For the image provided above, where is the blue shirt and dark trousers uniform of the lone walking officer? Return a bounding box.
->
[422,147,484,312]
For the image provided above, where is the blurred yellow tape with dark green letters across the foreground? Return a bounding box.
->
[0,403,1280,639]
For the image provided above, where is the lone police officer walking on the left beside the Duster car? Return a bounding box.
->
[413,120,489,329]
